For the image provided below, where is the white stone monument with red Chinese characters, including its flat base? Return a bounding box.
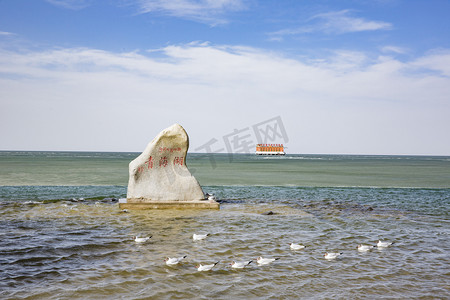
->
[119,124,219,209]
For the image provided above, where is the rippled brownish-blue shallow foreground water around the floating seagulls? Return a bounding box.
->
[0,187,450,299]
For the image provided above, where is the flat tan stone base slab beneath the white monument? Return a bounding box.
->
[119,199,220,210]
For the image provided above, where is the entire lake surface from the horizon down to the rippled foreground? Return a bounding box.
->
[0,152,450,299]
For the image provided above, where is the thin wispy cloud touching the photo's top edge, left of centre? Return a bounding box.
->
[137,0,245,25]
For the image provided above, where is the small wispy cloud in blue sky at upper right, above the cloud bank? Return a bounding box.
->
[269,10,392,40]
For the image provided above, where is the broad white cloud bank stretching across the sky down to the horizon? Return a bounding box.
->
[0,43,450,155]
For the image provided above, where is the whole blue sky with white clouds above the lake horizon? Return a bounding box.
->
[0,0,450,155]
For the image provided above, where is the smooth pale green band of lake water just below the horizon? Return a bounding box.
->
[0,151,450,188]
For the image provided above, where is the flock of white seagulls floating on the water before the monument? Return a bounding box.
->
[133,233,394,272]
